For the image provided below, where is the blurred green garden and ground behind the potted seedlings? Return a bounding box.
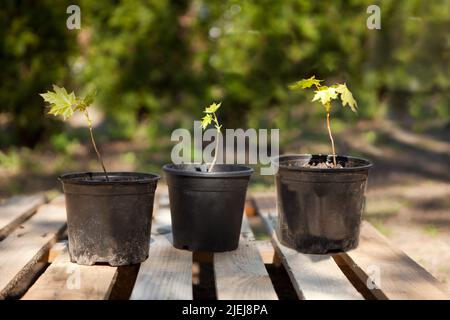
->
[0,0,450,290]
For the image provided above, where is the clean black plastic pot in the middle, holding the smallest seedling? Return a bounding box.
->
[163,164,253,252]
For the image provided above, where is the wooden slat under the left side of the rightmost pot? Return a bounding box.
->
[255,196,362,300]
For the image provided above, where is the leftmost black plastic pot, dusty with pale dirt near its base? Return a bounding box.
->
[59,172,160,266]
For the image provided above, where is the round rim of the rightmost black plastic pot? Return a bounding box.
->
[271,153,373,173]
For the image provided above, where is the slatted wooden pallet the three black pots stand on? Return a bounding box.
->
[0,190,449,300]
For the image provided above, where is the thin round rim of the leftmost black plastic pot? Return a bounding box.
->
[58,171,161,185]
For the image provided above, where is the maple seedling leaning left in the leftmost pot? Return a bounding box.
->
[39,85,109,181]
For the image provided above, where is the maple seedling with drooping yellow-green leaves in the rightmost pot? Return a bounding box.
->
[289,76,358,167]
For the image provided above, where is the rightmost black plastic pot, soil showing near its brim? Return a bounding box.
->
[273,155,372,254]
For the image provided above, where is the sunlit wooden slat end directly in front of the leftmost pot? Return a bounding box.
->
[22,248,118,300]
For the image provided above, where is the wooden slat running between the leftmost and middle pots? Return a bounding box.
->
[130,195,193,300]
